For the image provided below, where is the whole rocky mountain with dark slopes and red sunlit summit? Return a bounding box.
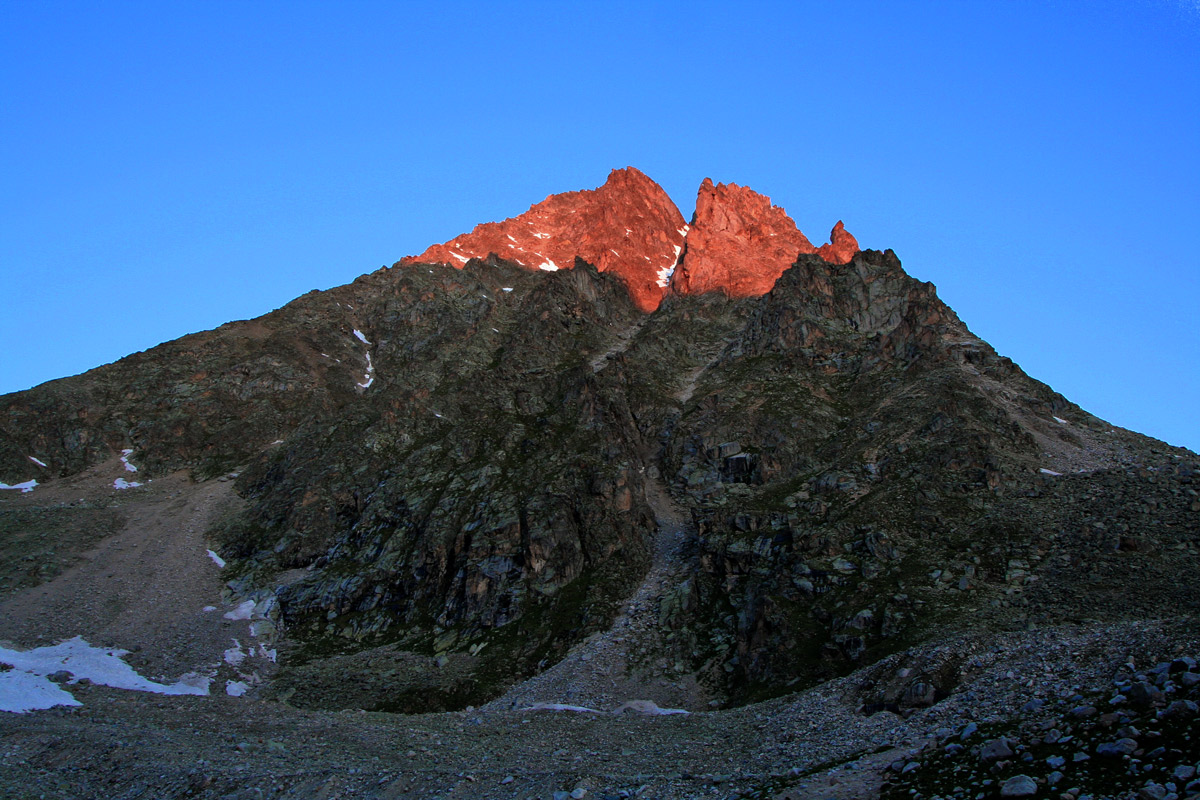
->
[0,168,1200,796]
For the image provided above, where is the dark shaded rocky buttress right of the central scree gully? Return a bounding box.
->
[628,251,1198,699]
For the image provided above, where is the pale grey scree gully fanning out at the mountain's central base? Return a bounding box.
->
[486,477,708,711]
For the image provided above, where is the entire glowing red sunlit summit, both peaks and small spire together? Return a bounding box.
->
[400,167,858,312]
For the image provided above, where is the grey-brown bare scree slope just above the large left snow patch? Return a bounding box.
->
[0,459,250,679]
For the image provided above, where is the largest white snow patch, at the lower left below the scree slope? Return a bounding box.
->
[0,636,210,710]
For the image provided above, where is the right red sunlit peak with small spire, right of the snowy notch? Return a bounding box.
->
[672,178,858,297]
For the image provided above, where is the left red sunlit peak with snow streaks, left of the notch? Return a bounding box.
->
[400,167,688,312]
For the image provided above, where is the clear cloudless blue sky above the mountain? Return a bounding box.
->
[0,0,1200,450]
